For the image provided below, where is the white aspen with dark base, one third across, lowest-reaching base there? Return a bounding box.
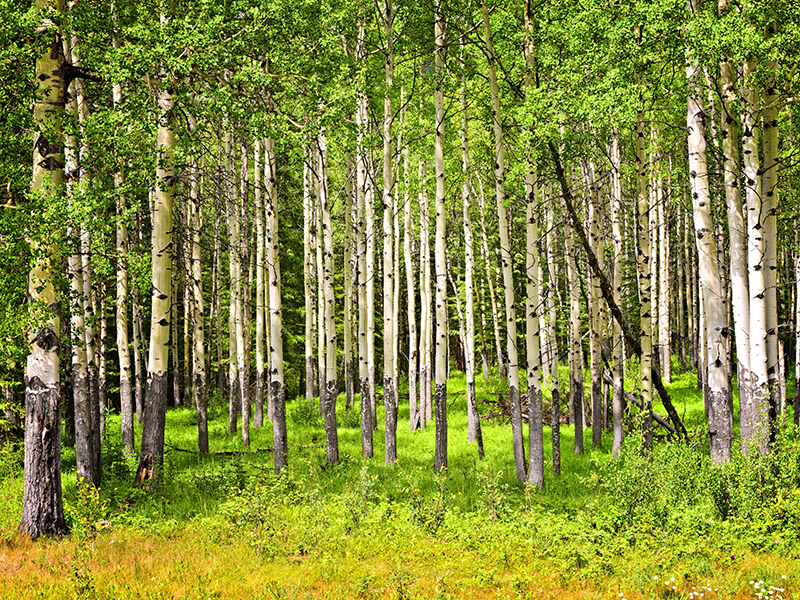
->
[264,138,288,475]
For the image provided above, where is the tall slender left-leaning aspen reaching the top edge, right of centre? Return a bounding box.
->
[481,1,525,482]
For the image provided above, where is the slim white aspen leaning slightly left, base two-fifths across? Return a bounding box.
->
[317,128,339,464]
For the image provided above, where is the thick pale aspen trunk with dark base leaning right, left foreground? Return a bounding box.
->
[136,68,175,483]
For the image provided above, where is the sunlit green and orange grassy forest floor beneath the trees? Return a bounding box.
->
[0,366,800,600]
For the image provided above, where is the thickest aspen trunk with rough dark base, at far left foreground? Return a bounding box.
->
[19,0,67,539]
